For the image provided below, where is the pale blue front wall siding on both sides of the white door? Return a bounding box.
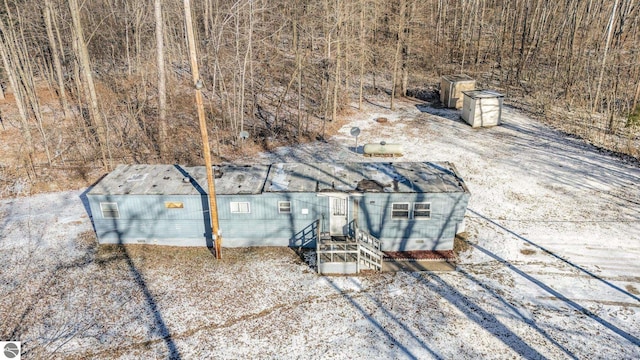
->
[88,193,469,251]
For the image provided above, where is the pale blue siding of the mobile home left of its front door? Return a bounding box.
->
[90,193,327,247]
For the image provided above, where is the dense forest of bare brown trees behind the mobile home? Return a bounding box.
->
[0,0,640,194]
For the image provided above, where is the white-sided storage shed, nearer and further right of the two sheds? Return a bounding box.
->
[462,90,504,127]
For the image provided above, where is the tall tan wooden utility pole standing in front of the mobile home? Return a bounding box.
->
[184,0,222,259]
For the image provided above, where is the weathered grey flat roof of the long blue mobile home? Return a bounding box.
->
[88,162,468,195]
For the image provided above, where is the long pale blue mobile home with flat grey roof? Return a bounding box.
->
[87,162,469,255]
